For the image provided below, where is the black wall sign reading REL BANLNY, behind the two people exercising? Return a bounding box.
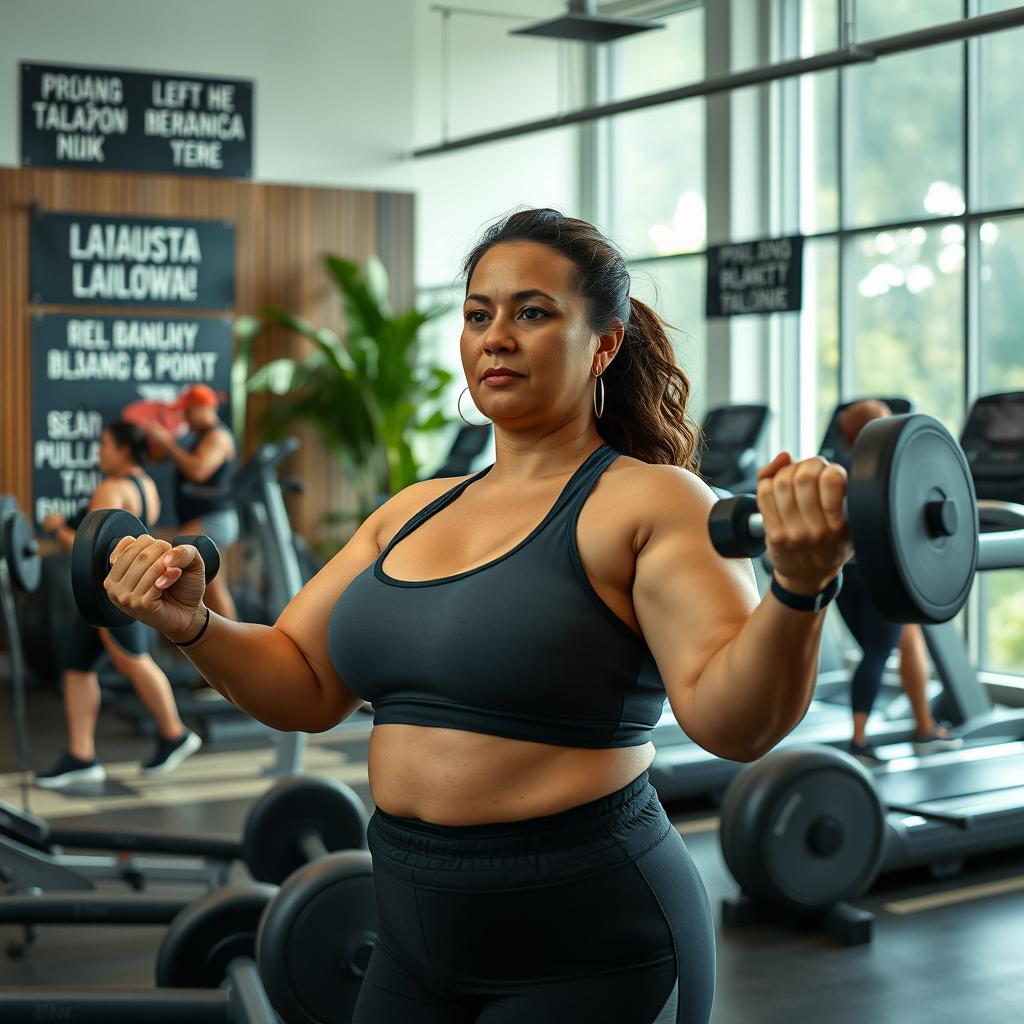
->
[32,313,232,524]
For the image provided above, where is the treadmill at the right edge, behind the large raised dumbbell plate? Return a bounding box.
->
[873,391,1024,877]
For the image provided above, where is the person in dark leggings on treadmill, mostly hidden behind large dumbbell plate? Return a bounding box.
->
[836,398,961,761]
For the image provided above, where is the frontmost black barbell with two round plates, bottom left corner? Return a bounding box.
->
[0,850,377,1024]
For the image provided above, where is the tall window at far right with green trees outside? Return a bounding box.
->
[790,0,1024,673]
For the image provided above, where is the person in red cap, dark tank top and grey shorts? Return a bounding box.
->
[146,384,239,620]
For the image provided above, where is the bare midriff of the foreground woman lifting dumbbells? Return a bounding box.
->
[370,725,654,825]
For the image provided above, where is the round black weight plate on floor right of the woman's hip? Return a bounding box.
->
[720,745,886,912]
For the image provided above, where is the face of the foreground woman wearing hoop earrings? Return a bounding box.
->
[461,242,618,430]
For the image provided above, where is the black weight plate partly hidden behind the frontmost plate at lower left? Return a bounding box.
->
[157,886,276,988]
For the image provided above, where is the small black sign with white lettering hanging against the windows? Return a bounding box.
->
[707,234,804,316]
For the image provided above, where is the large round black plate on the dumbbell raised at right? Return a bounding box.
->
[847,414,978,623]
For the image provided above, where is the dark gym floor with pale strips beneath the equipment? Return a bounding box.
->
[0,690,1024,1024]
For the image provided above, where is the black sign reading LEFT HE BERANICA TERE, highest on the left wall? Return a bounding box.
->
[22,63,253,178]
